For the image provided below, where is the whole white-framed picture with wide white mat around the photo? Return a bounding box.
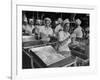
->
[11,2,97,80]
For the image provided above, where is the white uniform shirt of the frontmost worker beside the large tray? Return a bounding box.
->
[59,31,71,51]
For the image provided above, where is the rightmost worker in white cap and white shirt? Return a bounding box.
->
[73,19,83,39]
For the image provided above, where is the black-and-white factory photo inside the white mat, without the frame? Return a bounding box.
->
[21,10,90,69]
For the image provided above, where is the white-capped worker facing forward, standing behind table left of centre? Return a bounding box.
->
[40,18,53,41]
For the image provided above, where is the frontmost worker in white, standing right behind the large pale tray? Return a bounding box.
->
[58,19,71,57]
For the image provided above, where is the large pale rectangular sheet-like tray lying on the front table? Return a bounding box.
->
[31,46,65,66]
